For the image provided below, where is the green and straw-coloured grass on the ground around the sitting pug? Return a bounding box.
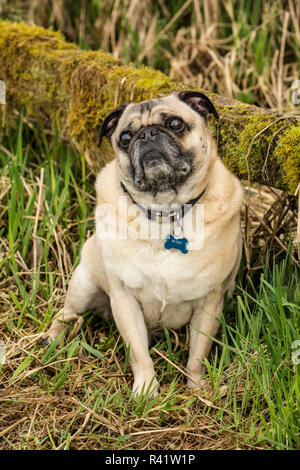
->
[0,121,300,449]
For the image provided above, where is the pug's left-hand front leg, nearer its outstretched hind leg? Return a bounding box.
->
[110,288,158,395]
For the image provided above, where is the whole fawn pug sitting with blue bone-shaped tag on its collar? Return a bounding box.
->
[45,91,243,395]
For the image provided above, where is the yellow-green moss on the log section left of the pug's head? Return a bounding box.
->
[0,21,183,166]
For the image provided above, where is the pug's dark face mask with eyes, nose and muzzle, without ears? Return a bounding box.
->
[117,110,193,193]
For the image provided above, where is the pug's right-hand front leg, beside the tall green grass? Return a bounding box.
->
[186,288,224,389]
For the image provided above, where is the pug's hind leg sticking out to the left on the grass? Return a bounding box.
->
[41,239,109,345]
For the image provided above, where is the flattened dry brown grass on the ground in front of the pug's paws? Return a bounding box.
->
[0,329,253,450]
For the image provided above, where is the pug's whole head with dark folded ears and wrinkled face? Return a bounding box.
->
[99,91,218,196]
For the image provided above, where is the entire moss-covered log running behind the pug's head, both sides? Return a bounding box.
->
[0,20,300,192]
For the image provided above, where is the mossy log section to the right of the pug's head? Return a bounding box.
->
[220,112,300,192]
